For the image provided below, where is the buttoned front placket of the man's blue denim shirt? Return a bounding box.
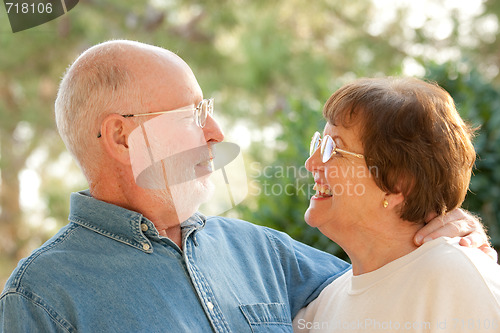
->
[184,230,231,332]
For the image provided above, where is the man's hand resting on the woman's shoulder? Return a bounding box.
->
[414,208,498,262]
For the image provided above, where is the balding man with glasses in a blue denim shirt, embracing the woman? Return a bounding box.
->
[0,41,492,333]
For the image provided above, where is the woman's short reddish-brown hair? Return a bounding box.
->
[323,77,476,222]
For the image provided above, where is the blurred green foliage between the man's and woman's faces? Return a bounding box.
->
[236,96,347,260]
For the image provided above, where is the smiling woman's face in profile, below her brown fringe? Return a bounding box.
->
[305,123,385,238]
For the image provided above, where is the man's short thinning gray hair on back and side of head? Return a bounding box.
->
[55,41,141,179]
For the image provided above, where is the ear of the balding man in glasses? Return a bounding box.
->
[100,114,135,165]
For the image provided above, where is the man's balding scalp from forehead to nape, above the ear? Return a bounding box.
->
[55,40,197,180]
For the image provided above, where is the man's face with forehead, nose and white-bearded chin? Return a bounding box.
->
[129,48,223,221]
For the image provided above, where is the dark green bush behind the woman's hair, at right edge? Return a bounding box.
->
[427,64,500,249]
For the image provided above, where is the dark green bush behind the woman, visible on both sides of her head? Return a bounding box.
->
[237,60,500,259]
